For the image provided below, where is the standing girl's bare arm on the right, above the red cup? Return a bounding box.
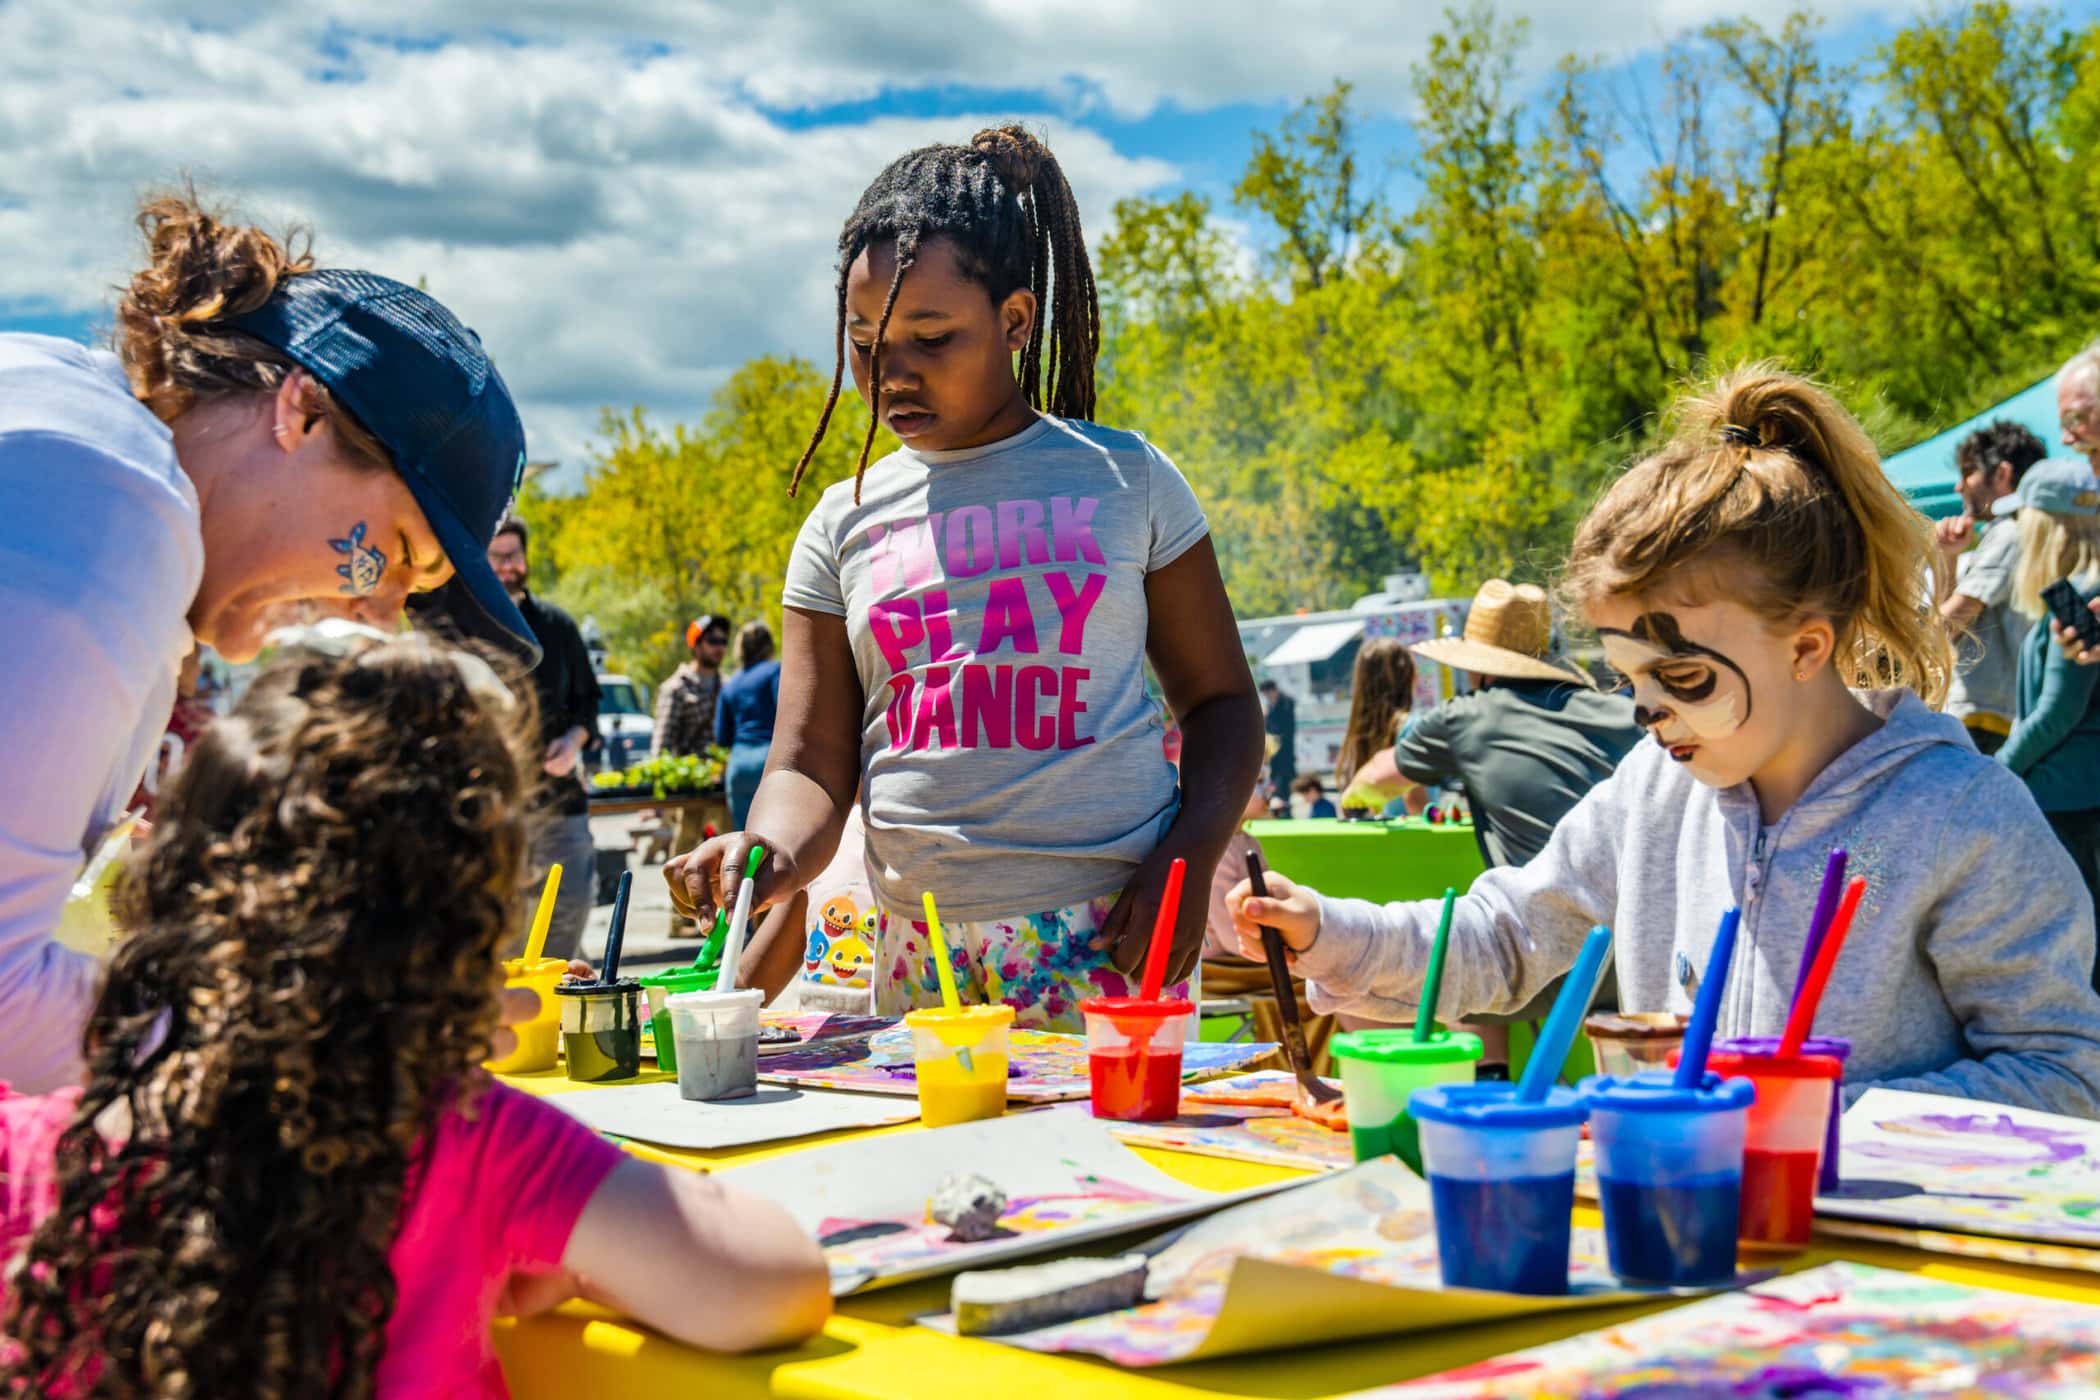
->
[1100,535,1262,982]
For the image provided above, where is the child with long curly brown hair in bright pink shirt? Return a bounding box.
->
[0,638,830,1396]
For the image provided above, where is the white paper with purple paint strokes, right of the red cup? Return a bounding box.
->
[1817,1089,2100,1247]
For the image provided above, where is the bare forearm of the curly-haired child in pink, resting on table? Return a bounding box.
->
[561,1157,832,1352]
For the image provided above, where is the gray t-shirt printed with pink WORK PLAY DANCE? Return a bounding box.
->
[783,416,1210,921]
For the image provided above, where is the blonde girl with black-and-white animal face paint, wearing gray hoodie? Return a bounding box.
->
[1229,365,2100,1117]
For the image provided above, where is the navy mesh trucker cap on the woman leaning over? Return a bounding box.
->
[225,269,540,663]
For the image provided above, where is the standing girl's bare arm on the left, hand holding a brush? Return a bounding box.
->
[664,607,863,919]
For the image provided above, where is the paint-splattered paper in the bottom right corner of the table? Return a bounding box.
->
[1365,1264,2100,1400]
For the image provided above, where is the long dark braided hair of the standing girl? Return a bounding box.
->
[788,126,1100,504]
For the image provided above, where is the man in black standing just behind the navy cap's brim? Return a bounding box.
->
[489,516,599,957]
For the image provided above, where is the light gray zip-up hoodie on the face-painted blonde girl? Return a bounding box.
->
[1285,691,2100,1119]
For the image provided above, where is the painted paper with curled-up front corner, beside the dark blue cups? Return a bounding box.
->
[944,1157,1663,1366]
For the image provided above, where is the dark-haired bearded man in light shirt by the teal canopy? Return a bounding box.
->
[1934,418,2041,754]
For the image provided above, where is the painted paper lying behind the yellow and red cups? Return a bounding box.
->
[758,1016,1275,1104]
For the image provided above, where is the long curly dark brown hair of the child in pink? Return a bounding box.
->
[0,638,538,1400]
